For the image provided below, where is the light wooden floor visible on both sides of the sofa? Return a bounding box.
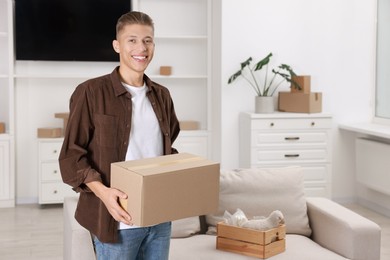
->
[0,204,390,260]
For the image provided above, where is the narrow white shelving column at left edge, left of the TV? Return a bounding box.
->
[0,0,15,208]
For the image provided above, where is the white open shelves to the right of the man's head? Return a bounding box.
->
[132,0,212,143]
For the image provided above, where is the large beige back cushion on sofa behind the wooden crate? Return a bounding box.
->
[206,166,311,236]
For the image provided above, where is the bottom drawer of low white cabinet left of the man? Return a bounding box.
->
[39,182,76,204]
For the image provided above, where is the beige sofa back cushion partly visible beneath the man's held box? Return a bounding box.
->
[171,216,200,238]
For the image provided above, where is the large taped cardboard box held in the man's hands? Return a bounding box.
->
[111,153,220,226]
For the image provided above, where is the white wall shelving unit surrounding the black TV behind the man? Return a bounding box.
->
[6,0,213,203]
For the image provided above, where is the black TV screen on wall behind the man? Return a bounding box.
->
[15,0,131,61]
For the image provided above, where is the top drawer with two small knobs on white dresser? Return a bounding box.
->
[252,118,332,130]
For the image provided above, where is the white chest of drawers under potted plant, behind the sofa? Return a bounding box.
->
[239,112,332,197]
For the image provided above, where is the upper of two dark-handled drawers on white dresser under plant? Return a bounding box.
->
[252,131,328,146]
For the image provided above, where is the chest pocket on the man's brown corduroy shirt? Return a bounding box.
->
[94,114,118,147]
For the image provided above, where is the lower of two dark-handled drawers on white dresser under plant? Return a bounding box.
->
[251,149,329,164]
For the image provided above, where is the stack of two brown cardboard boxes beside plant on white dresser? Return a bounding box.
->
[279,76,322,113]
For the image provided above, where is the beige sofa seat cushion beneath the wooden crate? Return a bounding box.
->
[169,235,347,260]
